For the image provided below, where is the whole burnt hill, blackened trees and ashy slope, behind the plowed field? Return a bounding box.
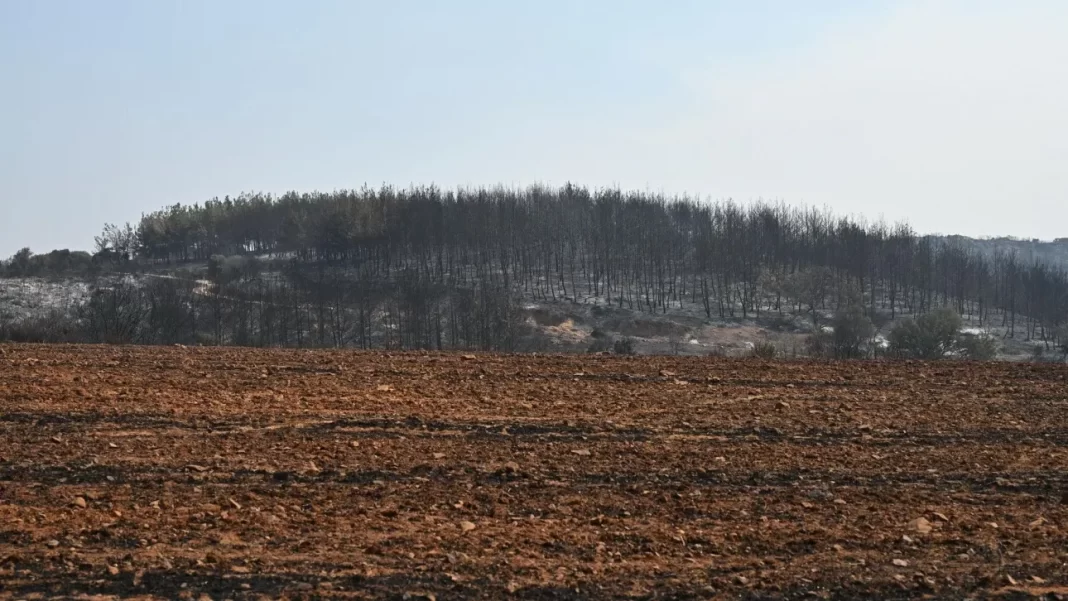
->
[0,185,1068,360]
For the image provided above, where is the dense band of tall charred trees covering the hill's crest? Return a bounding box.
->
[122,185,1068,331]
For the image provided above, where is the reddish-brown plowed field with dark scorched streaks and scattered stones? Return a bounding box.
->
[0,346,1068,600]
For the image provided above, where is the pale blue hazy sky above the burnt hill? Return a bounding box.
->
[0,0,1068,256]
